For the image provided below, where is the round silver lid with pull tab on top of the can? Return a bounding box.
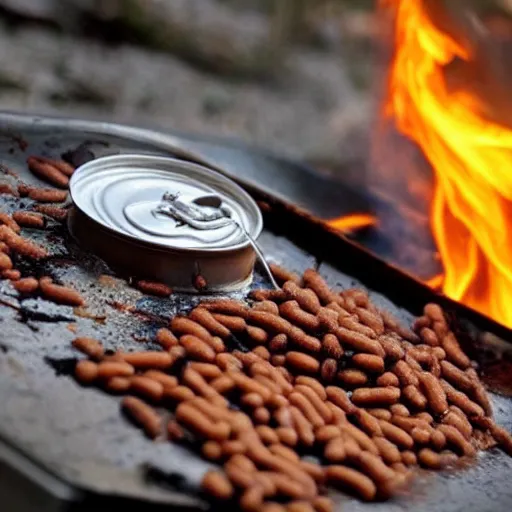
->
[69,154,263,251]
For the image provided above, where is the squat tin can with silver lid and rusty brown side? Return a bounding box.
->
[68,155,263,292]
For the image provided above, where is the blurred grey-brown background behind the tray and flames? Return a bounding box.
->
[0,0,512,181]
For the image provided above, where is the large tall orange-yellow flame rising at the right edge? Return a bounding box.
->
[380,0,512,327]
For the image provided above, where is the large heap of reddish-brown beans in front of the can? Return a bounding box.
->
[73,267,512,512]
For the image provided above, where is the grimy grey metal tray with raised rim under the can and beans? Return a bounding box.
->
[0,114,512,512]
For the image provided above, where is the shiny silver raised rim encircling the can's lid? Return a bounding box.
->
[69,153,263,253]
